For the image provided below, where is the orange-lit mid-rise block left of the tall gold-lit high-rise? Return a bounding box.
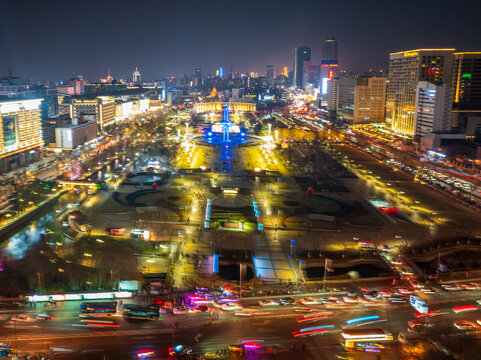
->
[354,77,386,123]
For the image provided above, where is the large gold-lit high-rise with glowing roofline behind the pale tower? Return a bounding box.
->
[386,49,454,135]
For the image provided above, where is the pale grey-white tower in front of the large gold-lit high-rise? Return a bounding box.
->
[414,81,453,136]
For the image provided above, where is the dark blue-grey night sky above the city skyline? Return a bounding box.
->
[0,0,481,81]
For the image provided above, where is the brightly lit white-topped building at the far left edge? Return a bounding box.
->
[0,99,43,173]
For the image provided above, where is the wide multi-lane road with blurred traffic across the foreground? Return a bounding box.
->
[4,291,481,360]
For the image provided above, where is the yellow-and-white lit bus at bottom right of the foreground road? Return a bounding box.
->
[341,329,393,351]
